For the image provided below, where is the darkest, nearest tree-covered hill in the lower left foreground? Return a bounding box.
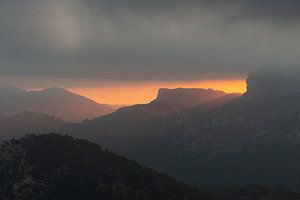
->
[0,134,208,200]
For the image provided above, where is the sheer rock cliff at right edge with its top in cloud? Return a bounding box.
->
[247,70,300,99]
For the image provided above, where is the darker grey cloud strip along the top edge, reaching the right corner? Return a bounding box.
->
[83,0,300,23]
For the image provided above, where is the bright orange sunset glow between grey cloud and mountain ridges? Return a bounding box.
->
[67,80,246,104]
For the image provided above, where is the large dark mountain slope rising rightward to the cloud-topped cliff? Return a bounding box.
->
[63,72,300,190]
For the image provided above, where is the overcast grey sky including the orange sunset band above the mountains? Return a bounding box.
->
[0,0,300,103]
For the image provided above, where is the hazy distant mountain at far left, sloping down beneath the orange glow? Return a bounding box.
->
[0,86,115,122]
